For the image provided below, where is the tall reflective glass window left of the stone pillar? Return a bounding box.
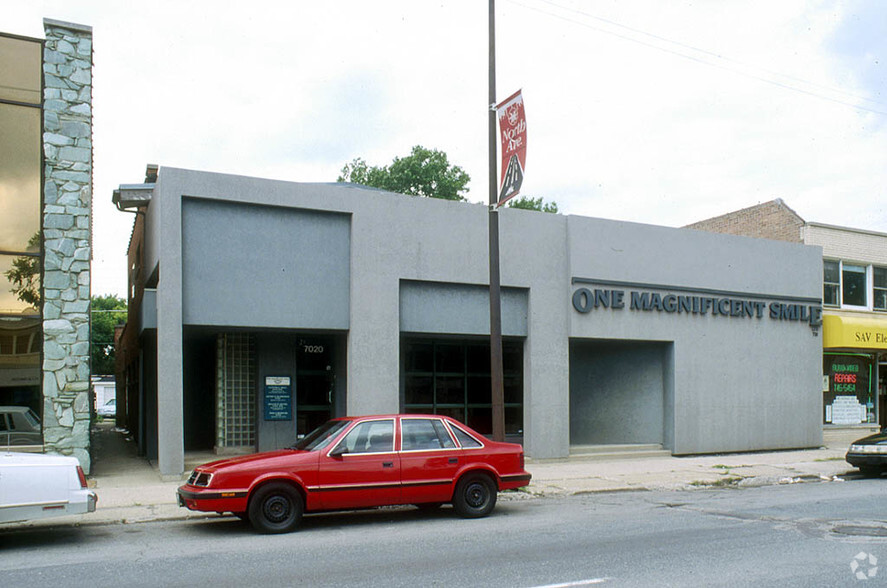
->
[0,35,43,446]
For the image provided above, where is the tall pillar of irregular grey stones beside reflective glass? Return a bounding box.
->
[43,19,92,472]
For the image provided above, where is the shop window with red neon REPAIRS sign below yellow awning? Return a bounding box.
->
[822,353,878,425]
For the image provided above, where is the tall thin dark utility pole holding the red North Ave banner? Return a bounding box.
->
[488,0,505,441]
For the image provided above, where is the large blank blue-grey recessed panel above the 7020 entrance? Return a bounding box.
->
[182,198,350,329]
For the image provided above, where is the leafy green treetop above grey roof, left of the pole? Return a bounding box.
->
[336,145,471,200]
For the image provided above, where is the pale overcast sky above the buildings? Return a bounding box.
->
[6,0,887,296]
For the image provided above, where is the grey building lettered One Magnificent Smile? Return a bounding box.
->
[115,168,822,473]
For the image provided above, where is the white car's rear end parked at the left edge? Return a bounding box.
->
[0,450,98,523]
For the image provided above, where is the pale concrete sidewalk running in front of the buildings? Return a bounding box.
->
[0,422,858,529]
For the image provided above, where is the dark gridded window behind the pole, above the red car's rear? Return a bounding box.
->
[403,341,523,435]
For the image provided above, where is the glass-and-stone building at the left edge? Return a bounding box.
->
[0,19,92,471]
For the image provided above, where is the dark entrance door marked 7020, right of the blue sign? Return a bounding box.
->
[296,337,336,435]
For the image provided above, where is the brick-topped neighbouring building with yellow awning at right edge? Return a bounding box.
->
[688,200,887,441]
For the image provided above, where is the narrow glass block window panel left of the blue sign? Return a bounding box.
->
[216,333,256,449]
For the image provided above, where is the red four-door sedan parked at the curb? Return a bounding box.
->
[178,415,530,533]
